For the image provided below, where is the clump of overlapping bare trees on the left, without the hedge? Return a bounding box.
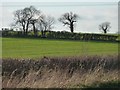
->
[12,6,55,36]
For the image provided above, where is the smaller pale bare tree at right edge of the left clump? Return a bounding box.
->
[38,15,55,37]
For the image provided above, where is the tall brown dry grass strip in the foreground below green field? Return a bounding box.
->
[2,55,120,88]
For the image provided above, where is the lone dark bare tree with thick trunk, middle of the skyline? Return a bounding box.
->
[58,12,78,33]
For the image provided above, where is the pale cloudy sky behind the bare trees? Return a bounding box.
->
[0,0,118,33]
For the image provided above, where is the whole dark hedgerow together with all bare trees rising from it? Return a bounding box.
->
[2,6,118,41]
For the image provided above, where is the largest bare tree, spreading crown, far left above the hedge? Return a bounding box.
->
[14,6,40,34]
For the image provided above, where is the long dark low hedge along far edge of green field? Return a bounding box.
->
[2,30,119,42]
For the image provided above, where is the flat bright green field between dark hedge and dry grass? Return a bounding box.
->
[2,38,118,58]
